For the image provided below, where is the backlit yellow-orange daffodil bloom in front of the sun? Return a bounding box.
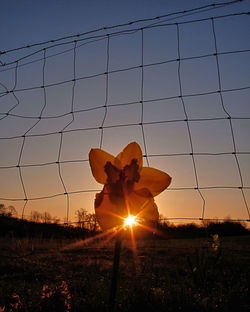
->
[89,142,171,230]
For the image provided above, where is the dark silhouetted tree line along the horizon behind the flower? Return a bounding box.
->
[0,204,250,239]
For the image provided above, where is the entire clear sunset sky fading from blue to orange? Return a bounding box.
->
[0,0,250,222]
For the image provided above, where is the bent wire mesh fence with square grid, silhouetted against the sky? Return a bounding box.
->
[0,0,250,224]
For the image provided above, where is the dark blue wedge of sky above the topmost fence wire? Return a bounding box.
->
[0,0,250,50]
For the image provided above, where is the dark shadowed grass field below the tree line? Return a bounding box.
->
[0,235,250,312]
